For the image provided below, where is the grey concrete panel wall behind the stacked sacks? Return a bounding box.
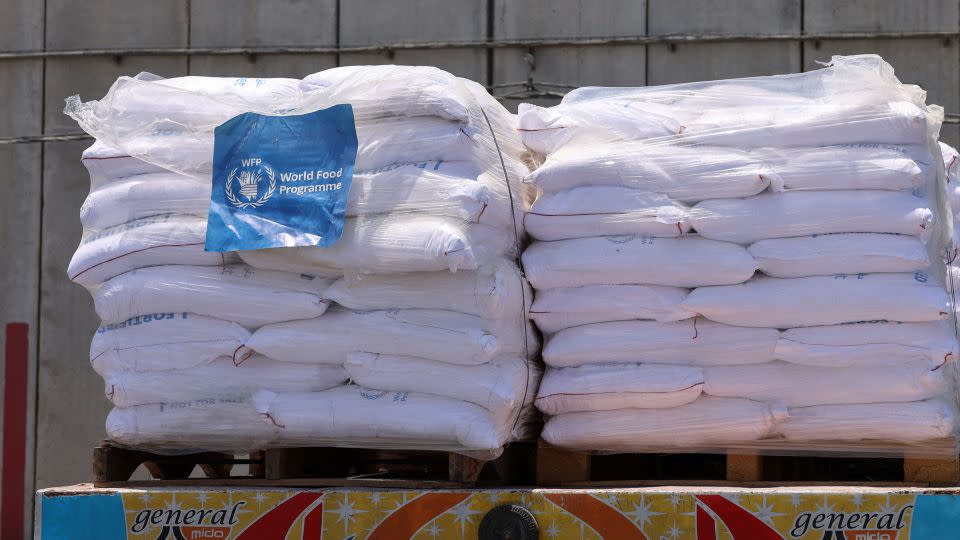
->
[0,0,960,536]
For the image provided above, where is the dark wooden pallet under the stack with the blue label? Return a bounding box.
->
[93,441,536,489]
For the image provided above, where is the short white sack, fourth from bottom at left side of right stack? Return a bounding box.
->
[530,285,690,334]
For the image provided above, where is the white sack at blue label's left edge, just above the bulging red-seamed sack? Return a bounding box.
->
[80,173,210,229]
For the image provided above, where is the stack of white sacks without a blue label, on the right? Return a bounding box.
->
[519,56,957,451]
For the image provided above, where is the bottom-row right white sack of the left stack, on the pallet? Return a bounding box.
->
[254,385,509,450]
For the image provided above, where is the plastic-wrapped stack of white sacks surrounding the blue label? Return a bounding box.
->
[67,66,540,454]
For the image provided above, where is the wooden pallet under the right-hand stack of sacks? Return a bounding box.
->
[536,441,960,487]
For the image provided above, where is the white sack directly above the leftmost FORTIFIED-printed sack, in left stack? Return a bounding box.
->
[93,264,330,328]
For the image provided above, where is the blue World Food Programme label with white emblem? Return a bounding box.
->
[204,105,357,251]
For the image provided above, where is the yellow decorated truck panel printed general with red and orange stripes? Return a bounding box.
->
[40,488,960,540]
